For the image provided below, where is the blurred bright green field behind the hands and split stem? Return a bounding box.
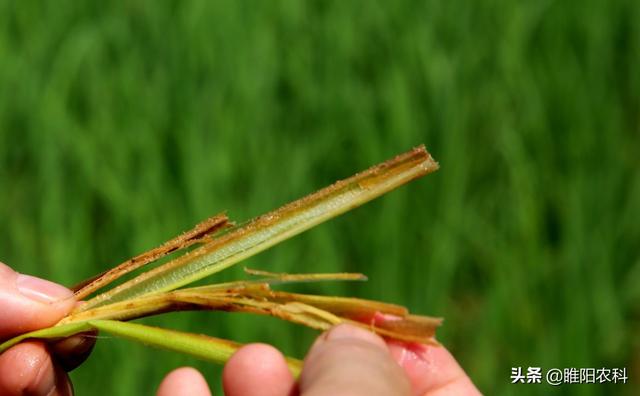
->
[0,0,640,395]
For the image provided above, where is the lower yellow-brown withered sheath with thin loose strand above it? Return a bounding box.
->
[61,274,441,344]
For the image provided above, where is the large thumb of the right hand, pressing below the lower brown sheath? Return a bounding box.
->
[300,325,411,396]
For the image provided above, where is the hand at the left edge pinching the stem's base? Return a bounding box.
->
[0,263,94,396]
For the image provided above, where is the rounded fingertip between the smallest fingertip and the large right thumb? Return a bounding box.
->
[222,344,295,396]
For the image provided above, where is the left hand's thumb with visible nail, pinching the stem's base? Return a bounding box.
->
[0,263,75,340]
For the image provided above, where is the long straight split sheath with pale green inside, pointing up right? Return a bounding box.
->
[80,146,438,310]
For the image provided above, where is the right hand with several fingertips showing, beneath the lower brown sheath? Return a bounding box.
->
[158,325,480,396]
